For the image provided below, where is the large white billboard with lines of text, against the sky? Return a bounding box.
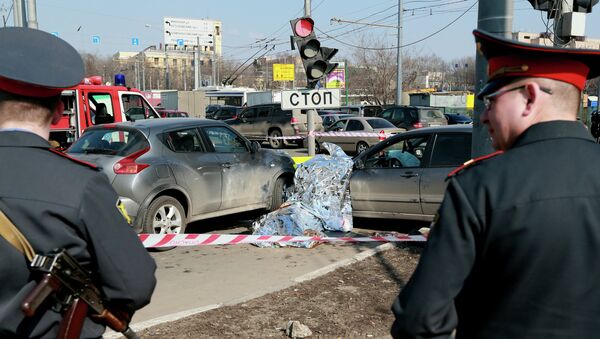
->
[163,17,221,46]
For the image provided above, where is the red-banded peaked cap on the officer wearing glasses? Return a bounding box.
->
[473,30,600,99]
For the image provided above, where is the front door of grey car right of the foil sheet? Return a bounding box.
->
[350,135,429,217]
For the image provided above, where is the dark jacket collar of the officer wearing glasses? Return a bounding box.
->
[511,120,595,148]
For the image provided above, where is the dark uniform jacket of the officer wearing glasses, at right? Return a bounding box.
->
[392,121,600,339]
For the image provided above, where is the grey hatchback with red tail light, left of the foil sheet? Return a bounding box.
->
[67,118,294,234]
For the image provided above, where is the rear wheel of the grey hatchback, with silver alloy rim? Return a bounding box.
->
[142,195,187,251]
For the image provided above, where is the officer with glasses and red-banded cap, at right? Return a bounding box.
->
[391,31,600,339]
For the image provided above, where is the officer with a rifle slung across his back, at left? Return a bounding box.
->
[0,27,156,338]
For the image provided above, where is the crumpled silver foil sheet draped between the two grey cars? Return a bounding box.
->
[252,142,354,248]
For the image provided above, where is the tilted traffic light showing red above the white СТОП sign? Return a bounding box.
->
[290,17,338,88]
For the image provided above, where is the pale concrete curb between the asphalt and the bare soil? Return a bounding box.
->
[103,243,396,339]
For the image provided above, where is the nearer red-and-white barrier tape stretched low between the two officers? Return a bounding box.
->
[139,233,427,248]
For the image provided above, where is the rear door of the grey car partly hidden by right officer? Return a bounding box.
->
[420,133,472,215]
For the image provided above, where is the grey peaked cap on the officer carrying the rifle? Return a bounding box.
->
[0,27,84,98]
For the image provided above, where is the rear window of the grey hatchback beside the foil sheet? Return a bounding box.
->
[67,128,150,156]
